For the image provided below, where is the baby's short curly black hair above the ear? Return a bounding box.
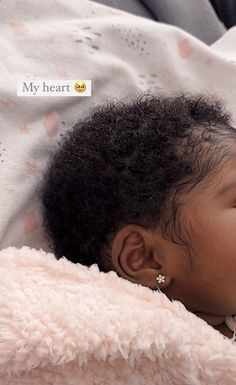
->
[39,93,236,272]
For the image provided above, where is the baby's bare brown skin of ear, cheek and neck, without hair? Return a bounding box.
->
[104,161,236,338]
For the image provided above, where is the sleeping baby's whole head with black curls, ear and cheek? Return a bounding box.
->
[41,94,236,315]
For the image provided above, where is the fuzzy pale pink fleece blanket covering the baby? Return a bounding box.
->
[0,246,236,385]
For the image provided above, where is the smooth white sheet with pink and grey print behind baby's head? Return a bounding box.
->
[0,0,236,251]
